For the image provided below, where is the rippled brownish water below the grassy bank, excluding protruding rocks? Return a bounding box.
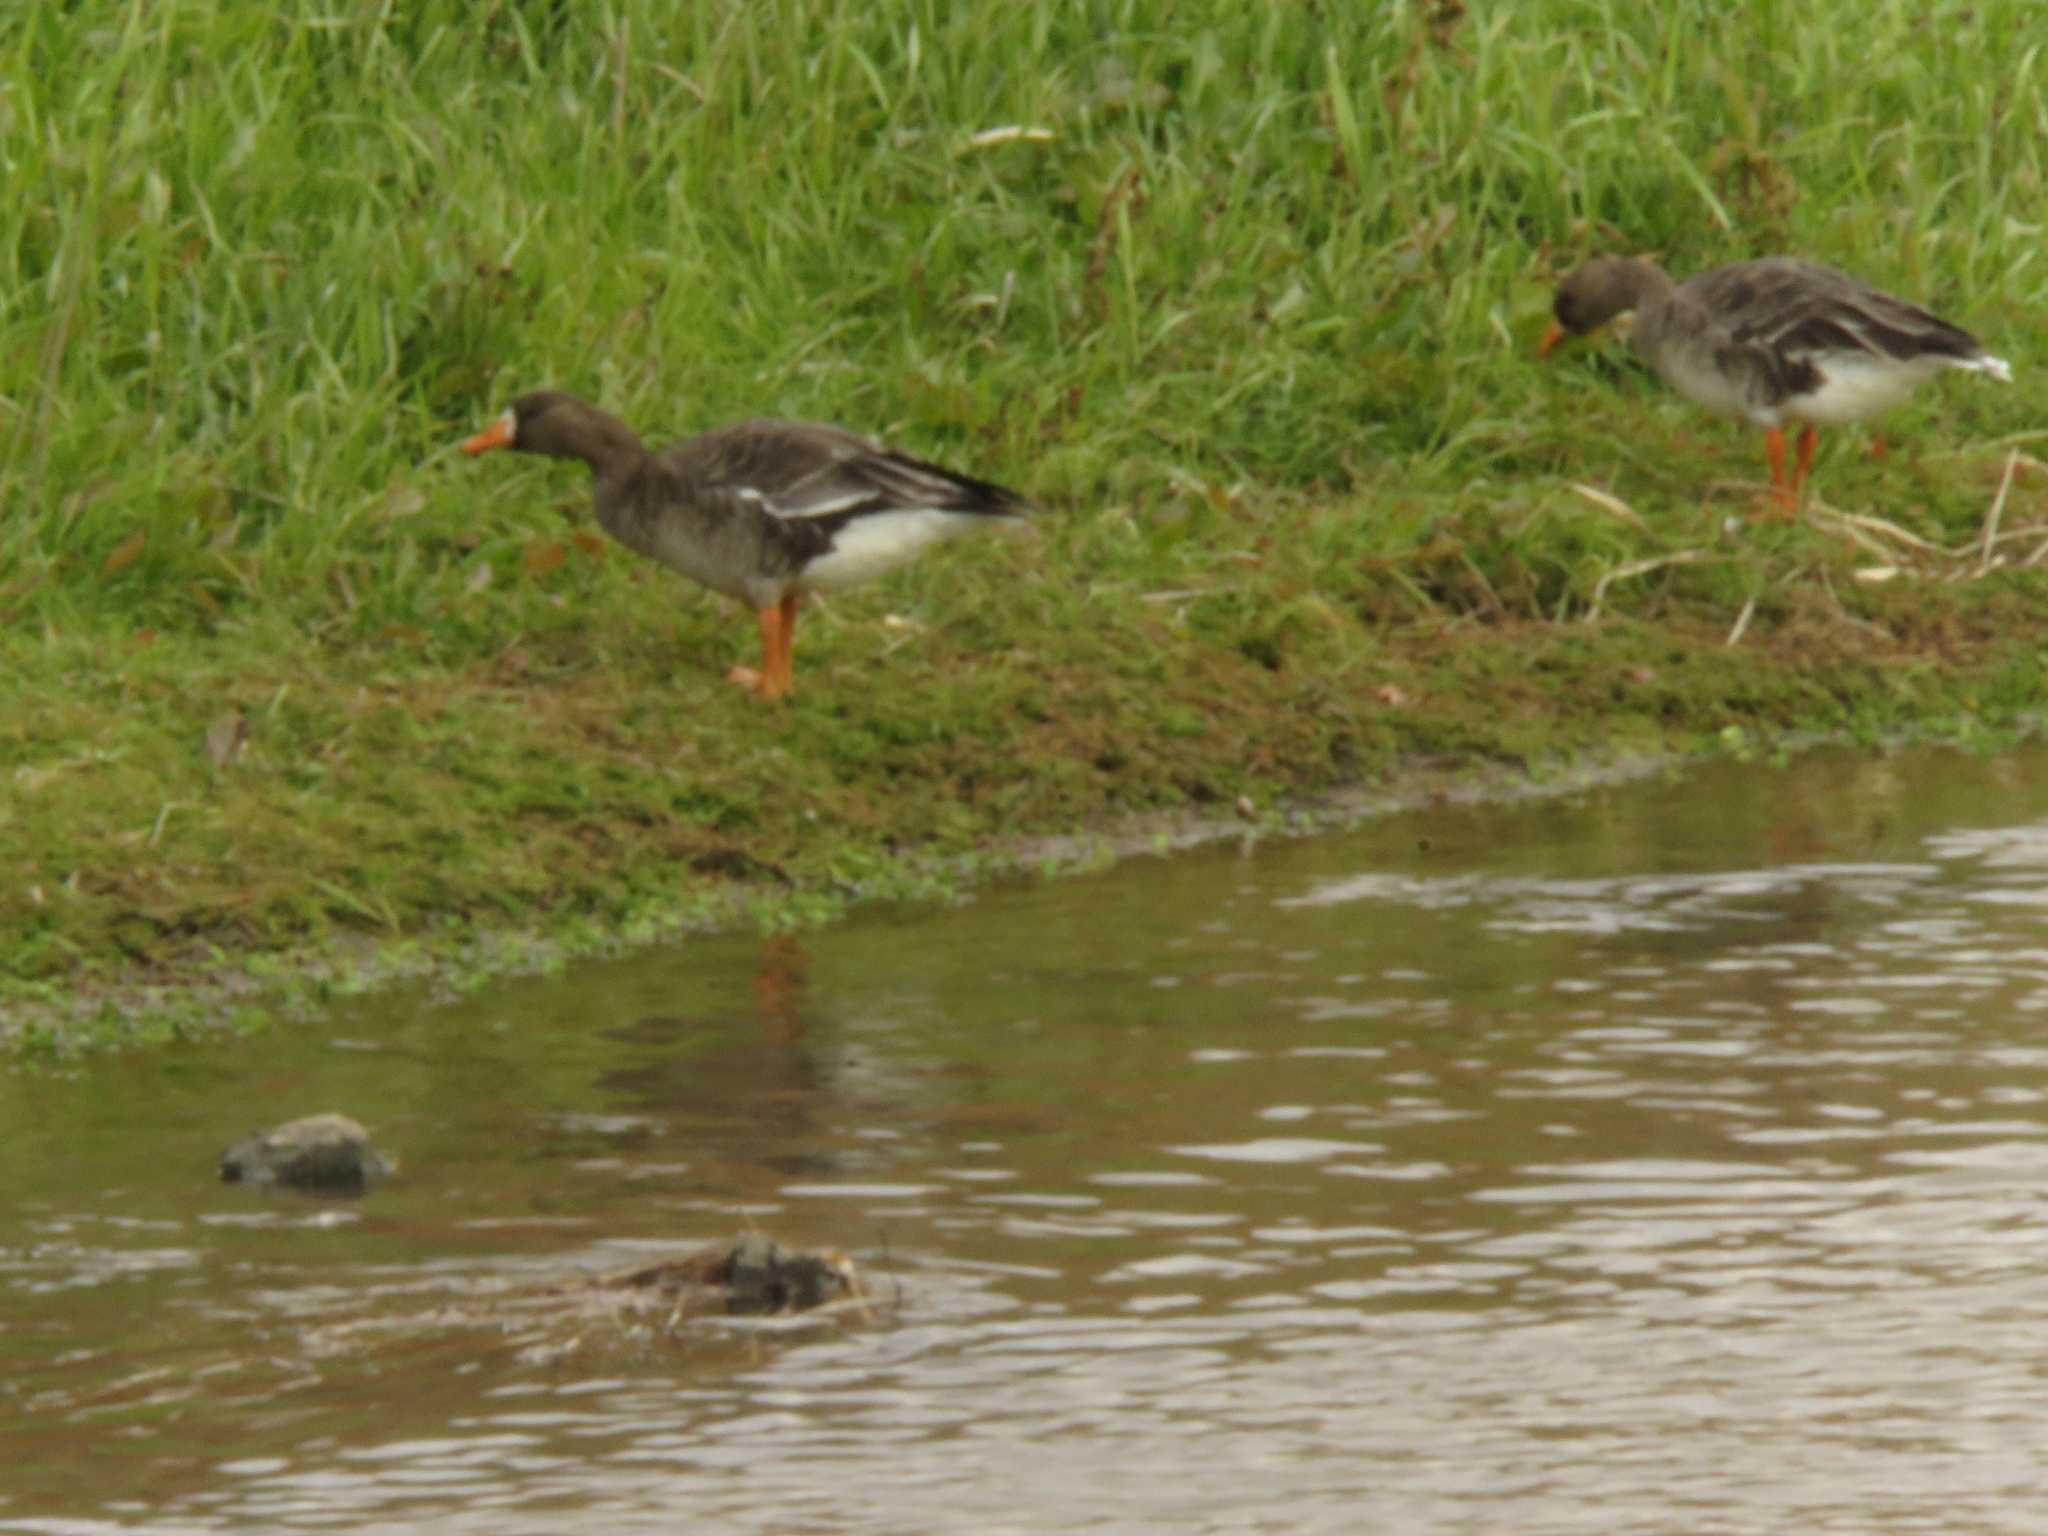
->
[0,752,2048,1536]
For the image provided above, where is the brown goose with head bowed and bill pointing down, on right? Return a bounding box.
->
[1542,256,2013,510]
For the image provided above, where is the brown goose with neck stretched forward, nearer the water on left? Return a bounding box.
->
[463,389,1030,698]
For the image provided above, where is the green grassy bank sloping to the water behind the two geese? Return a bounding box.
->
[0,0,2048,1028]
